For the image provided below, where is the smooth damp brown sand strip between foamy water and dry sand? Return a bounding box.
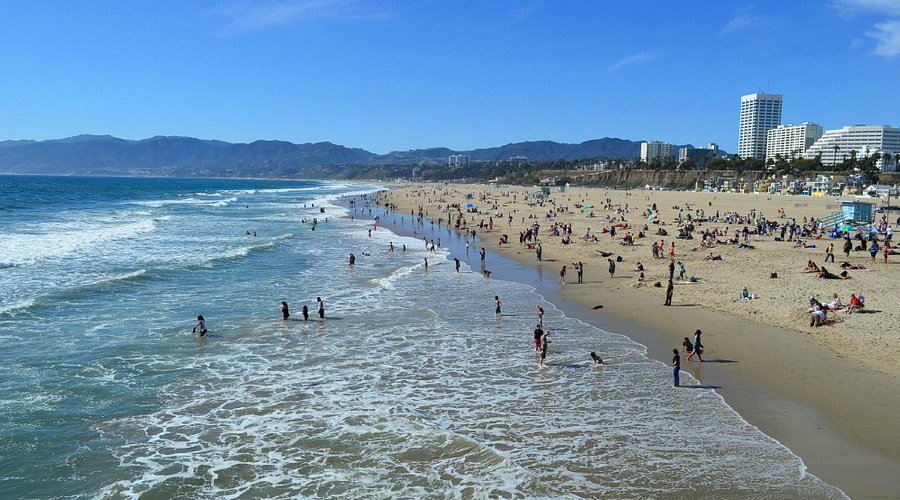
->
[370,185,900,498]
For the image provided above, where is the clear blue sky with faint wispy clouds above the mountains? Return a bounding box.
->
[0,0,900,153]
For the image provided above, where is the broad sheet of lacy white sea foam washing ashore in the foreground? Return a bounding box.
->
[100,260,843,498]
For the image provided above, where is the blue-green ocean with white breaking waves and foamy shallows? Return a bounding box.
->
[0,176,845,499]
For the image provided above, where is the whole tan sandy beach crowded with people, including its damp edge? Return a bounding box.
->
[380,184,900,498]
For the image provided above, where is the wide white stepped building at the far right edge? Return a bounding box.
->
[803,125,900,171]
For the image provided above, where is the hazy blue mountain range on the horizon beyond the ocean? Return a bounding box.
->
[0,135,716,177]
